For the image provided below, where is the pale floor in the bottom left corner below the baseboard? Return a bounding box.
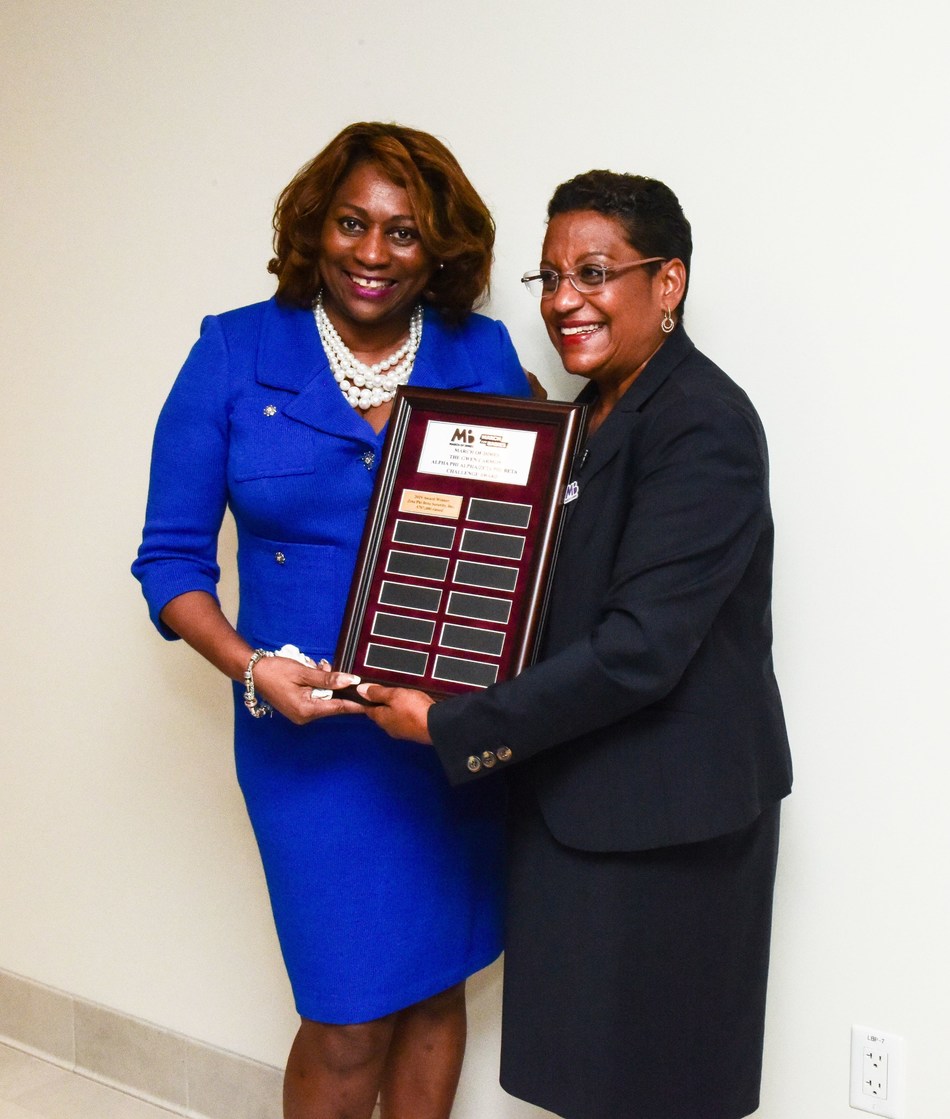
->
[0,1045,172,1119]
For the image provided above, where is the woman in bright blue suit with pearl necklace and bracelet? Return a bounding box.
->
[133,123,528,1119]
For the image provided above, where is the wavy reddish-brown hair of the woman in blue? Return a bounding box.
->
[267,121,495,322]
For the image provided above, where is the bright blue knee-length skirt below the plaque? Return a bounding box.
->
[235,689,504,1024]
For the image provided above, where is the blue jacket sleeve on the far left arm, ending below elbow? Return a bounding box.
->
[132,317,229,640]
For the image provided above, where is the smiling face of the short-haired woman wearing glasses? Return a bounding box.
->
[540,210,685,399]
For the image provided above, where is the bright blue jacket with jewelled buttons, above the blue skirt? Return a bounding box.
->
[132,299,528,659]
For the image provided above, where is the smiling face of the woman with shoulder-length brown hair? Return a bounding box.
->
[320,162,434,351]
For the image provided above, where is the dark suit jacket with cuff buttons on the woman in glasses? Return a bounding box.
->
[429,327,791,850]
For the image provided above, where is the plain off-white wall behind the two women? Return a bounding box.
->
[0,0,950,1119]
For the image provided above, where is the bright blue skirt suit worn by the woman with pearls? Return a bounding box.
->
[133,299,527,1023]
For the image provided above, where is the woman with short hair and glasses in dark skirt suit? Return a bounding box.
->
[360,171,791,1119]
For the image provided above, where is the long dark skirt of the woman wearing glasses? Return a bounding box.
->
[501,790,780,1119]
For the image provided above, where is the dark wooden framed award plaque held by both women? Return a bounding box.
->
[333,387,586,696]
